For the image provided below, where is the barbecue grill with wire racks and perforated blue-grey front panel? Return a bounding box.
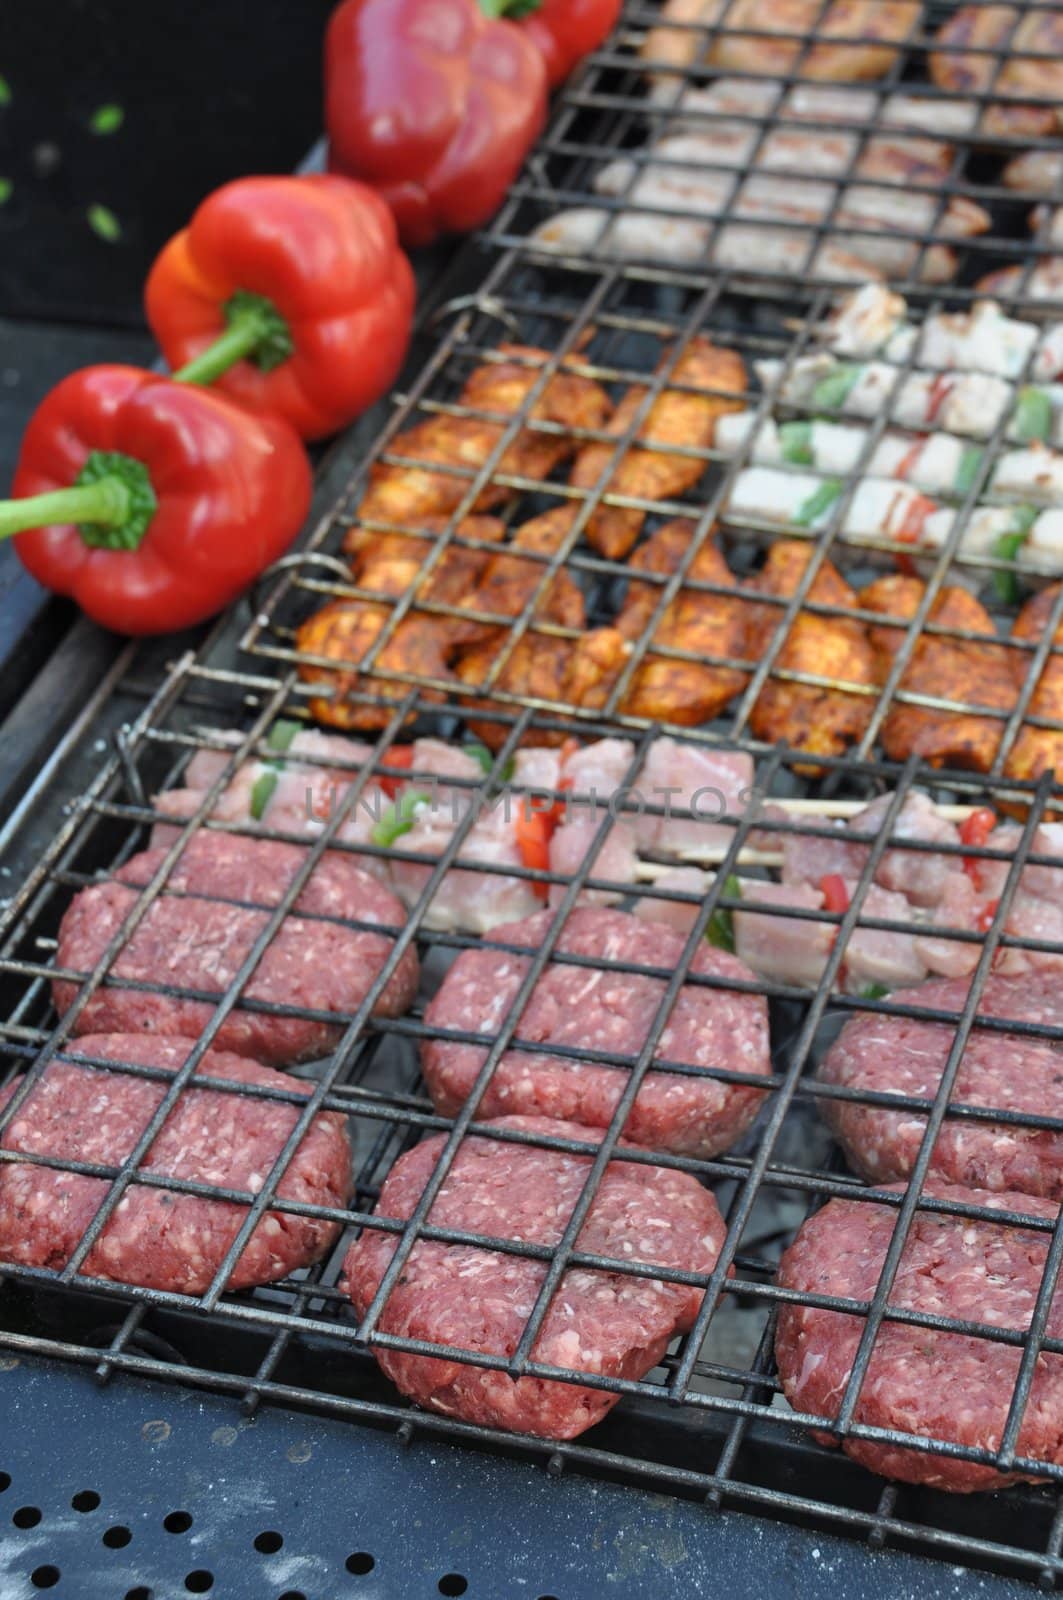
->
[0,5,1063,1600]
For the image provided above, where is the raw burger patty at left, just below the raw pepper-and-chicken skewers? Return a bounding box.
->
[54,832,418,1066]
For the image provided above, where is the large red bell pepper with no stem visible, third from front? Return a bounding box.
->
[325,0,548,245]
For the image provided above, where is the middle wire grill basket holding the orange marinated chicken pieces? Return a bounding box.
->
[243,254,1063,790]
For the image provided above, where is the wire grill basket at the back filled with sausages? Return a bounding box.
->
[493,0,1060,299]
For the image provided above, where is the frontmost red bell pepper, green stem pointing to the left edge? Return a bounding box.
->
[0,366,312,634]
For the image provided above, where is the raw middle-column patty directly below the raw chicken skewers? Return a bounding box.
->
[423,906,770,1157]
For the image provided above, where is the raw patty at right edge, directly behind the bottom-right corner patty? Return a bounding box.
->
[820,974,1063,1200]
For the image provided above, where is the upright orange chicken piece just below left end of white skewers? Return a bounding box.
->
[748,539,876,773]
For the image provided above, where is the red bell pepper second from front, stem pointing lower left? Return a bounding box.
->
[144,173,415,438]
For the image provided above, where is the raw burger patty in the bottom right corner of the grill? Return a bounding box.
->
[775,1182,1063,1493]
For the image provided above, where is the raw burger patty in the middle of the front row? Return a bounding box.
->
[344,1117,725,1438]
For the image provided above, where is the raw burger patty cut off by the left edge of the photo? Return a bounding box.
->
[0,1034,351,1294]
